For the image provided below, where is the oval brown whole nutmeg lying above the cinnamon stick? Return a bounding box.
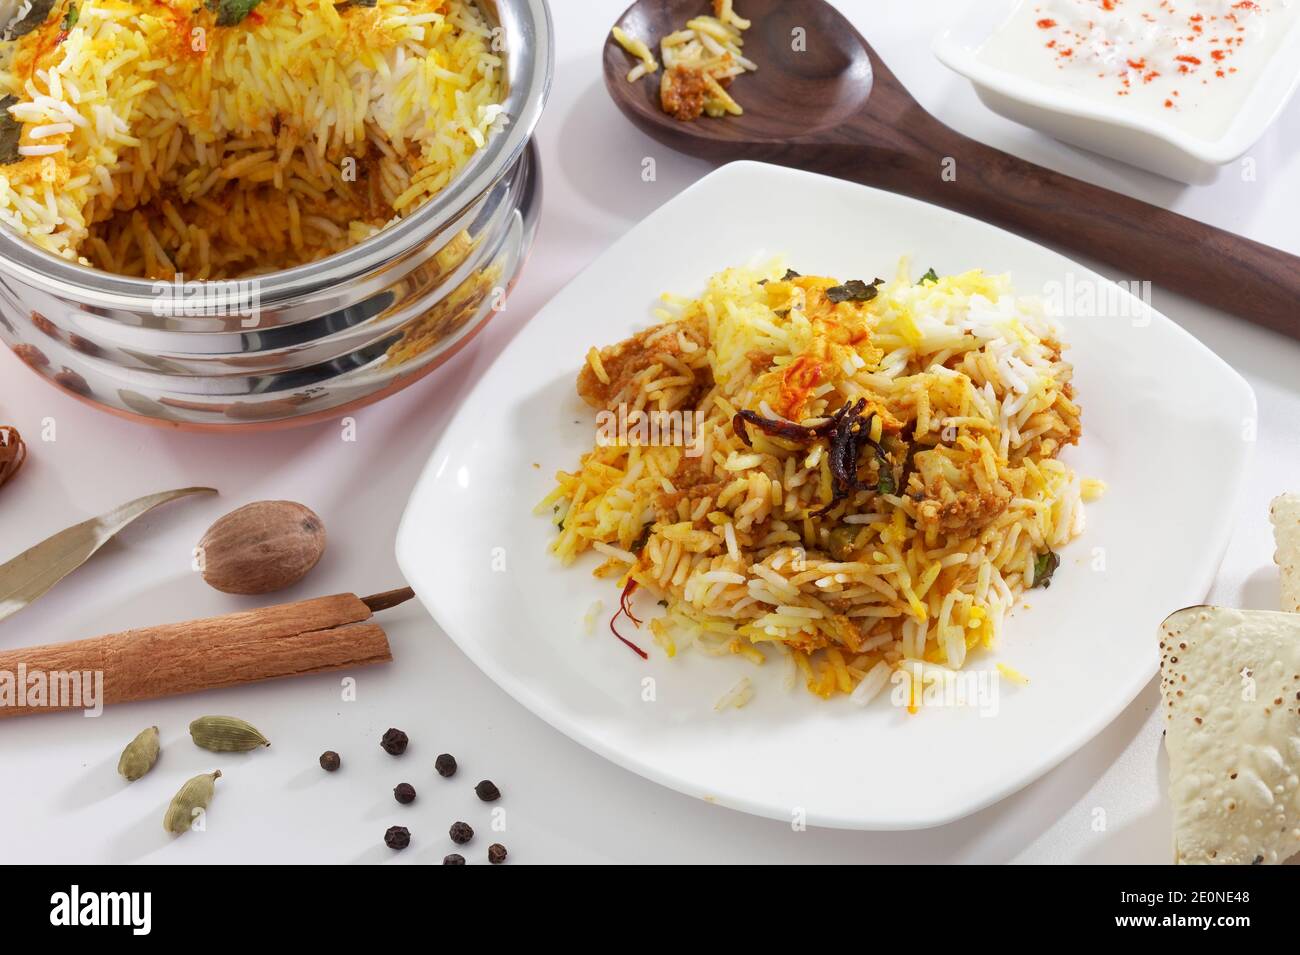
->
[199,500,325,594]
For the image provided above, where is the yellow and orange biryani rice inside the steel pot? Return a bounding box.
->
[0,0,506,279]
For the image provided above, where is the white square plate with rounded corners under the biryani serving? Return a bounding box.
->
[398,162,1255,829]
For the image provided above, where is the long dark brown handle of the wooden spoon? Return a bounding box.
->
[818,94,1300,338]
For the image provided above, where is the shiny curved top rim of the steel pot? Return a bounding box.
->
[0,0,555,312]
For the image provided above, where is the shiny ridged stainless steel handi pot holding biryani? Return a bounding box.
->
[0,0,555,430]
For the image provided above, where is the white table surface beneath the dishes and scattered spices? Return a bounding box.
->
[0,0,1300,863]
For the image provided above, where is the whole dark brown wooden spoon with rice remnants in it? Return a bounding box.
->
[605,0,1300,338]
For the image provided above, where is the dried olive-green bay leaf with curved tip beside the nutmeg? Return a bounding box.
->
[0,487,217,620]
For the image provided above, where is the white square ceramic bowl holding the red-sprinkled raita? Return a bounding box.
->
[933,0,1300,183]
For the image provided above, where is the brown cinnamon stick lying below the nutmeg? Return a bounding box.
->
[0,591,402,719]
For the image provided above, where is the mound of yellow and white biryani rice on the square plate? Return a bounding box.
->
[538,262,1101,703]
